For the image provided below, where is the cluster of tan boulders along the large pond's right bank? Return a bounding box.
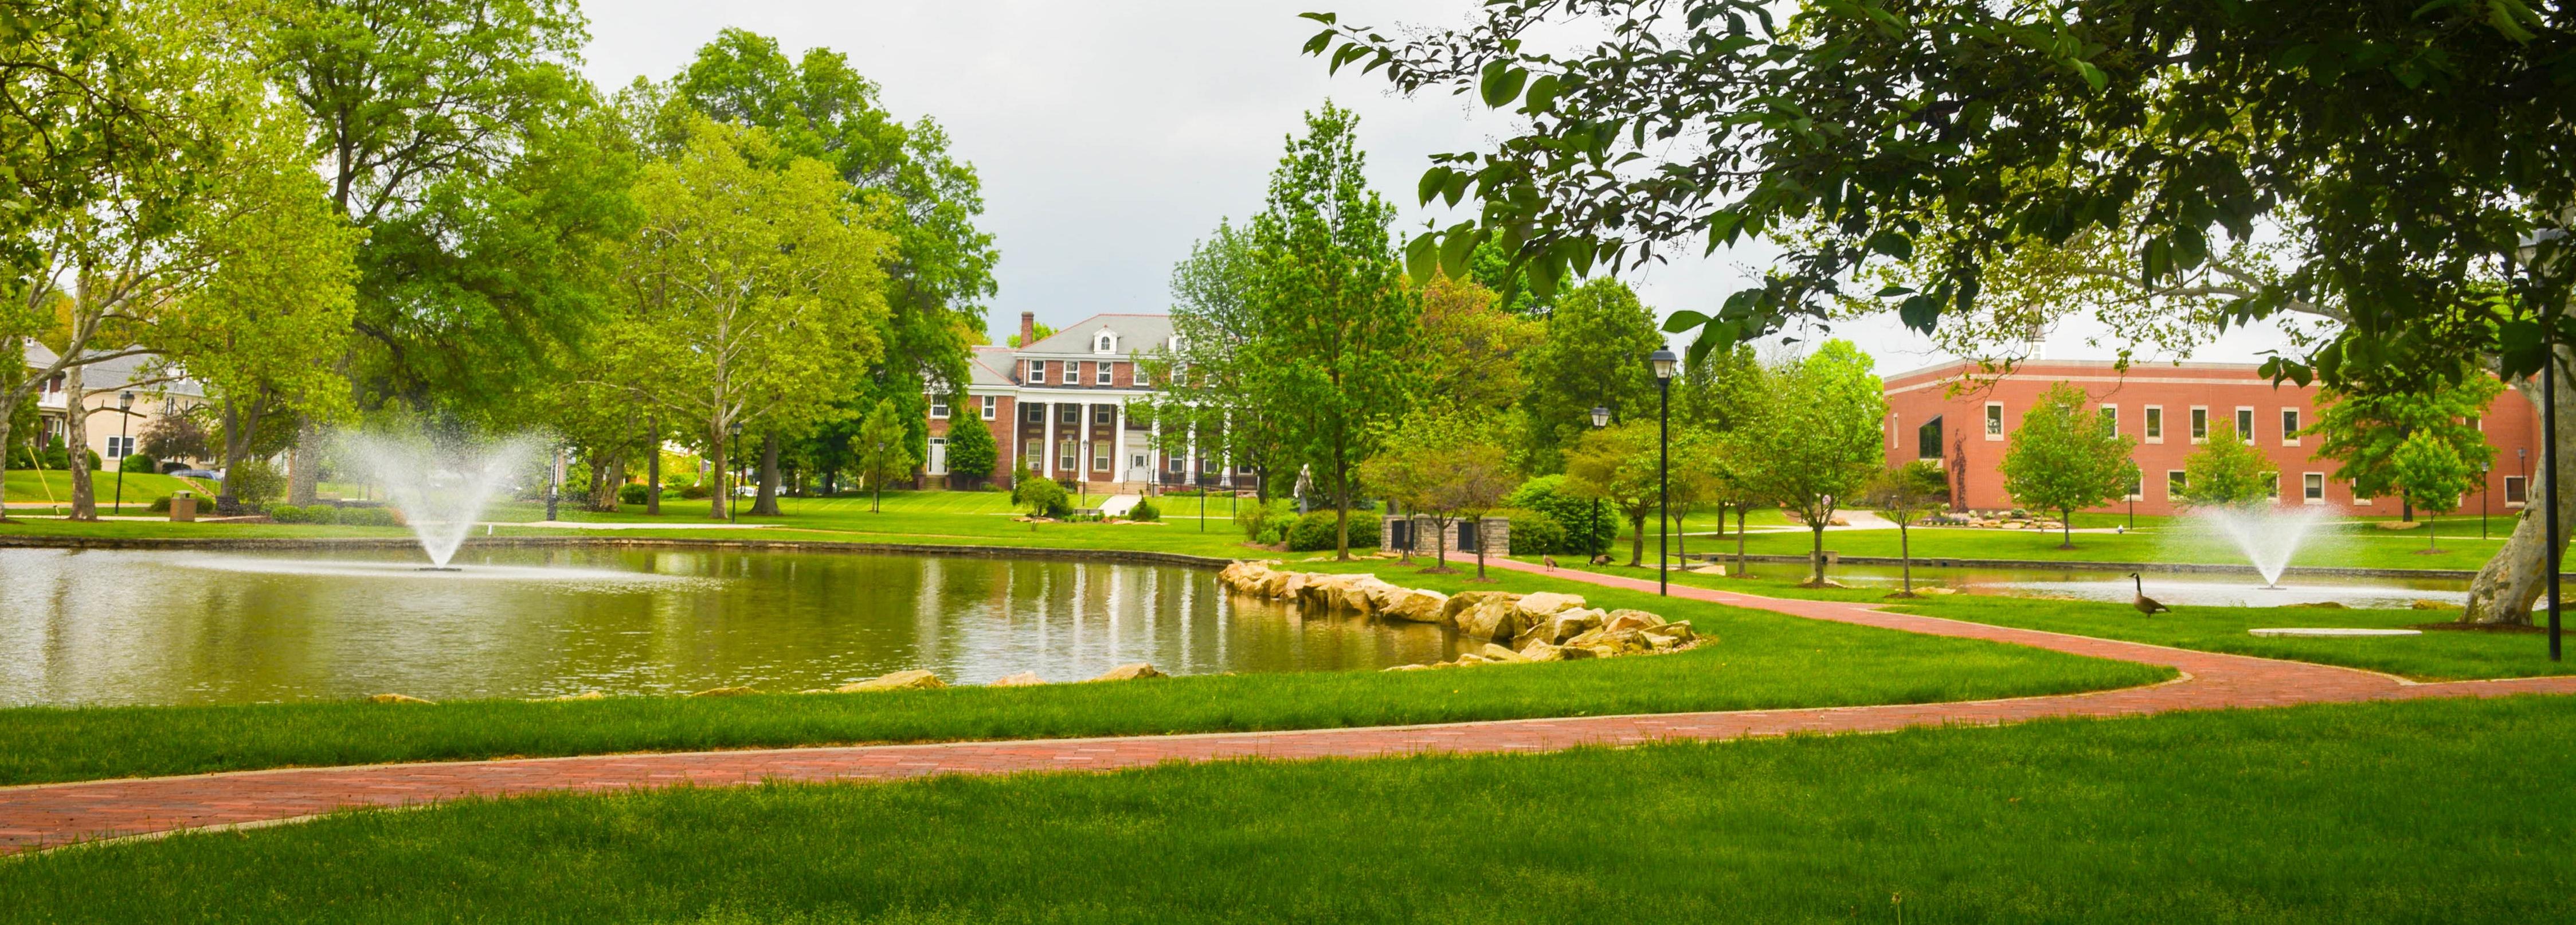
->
[1216,561,1700,670]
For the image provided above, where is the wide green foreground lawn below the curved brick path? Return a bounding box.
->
[0,698,2576,925]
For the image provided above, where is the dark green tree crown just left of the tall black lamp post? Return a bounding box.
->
[1520,278,1664,471]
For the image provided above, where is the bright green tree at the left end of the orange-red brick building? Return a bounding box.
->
[1728,340,1888,585]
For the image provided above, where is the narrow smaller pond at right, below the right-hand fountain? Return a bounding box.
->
[1754,561,2468,608]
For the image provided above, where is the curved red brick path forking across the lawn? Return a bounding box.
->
[0,561,2576,856]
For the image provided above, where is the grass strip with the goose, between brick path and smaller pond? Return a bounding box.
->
[1561,564,2576,680]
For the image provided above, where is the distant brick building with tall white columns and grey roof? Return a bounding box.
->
[922,312,1252,492]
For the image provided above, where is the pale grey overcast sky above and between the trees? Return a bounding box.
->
[585,0,2280,371]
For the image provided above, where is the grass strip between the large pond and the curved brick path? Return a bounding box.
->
[0,567,2171,783]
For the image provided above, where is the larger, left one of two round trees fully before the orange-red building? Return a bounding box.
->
[2004,381,2138,549]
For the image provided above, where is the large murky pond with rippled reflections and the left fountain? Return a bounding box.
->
[0,547,1458,706]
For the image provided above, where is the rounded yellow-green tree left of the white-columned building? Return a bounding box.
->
[621,119,888,518]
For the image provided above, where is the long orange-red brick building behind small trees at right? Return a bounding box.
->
[1886,361,2540,516]
